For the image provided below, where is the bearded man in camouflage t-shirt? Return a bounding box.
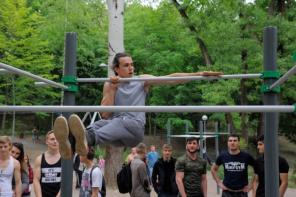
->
[175,137,207,197]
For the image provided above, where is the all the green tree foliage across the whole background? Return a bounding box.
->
[0,0,296,142]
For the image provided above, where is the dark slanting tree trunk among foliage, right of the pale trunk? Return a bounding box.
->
[172,0,213,65]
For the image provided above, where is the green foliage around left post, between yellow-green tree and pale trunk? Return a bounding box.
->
[31,0,108,105]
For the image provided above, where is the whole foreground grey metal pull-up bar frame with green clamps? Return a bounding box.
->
[0,27,296,197]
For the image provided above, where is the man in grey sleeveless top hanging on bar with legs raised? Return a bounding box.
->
[55,53,223,158]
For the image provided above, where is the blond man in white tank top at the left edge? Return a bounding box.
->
[0,136,22,197]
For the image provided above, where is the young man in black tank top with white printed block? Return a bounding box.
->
[33,131,62,197]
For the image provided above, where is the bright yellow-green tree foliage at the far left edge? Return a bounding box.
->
[0,0,57,105]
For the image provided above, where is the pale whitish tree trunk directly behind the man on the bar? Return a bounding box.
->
[105,0,124,188]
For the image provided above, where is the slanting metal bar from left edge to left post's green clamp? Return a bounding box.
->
[0,62,68,89]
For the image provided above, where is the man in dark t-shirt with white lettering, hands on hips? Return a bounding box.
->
[211,134,255,197]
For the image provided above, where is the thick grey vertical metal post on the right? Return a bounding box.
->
[263,27,279,197]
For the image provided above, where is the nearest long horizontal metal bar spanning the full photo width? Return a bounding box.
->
[0,105,296,113]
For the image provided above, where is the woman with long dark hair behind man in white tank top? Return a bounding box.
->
[11,142,31,197]
